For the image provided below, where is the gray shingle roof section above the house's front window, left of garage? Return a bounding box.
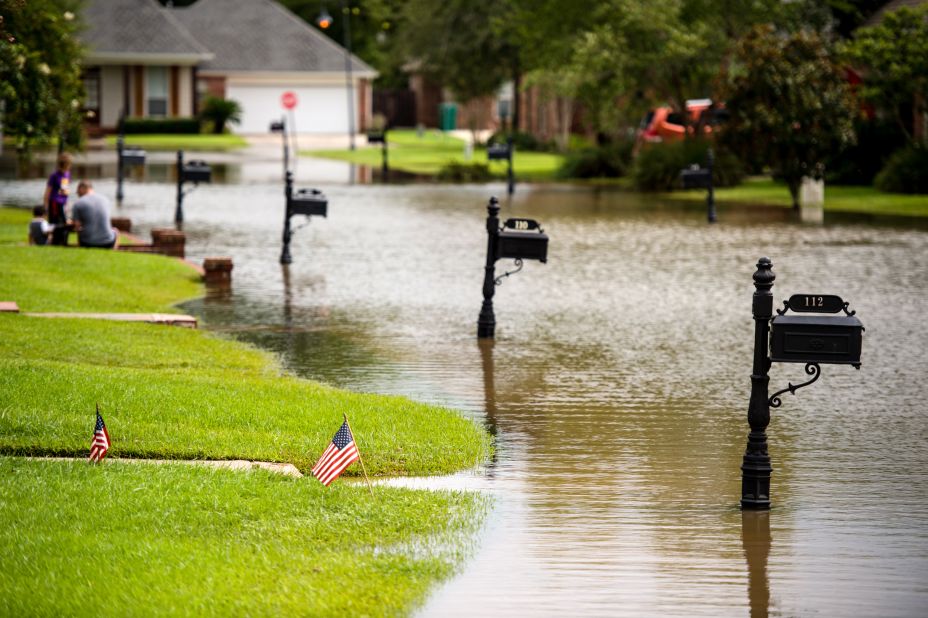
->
[80,0,212,63]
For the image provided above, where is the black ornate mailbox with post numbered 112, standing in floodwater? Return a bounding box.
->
[741,257,864,509]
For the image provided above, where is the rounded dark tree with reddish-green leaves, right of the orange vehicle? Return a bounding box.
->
[721,25,855,208]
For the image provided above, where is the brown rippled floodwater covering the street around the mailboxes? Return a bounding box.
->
[0,160,928,617]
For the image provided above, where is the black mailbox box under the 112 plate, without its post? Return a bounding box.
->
[770,315,864,367]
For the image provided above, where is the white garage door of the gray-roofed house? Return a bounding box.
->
[226,84,358,133]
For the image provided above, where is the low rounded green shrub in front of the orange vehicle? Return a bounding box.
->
[631,139,744,191]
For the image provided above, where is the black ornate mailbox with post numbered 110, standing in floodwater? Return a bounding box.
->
[477,197,548,339]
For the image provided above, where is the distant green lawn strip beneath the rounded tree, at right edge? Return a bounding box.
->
[661,178,928,217]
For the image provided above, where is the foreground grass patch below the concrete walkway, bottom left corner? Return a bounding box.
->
[0,458,486,616]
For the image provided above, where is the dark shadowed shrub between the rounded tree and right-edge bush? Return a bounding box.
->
[825,120,906,186]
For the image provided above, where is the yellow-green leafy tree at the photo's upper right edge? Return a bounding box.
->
[845,5,928,142]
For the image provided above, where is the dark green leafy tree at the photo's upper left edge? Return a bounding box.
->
[0,0,84,152]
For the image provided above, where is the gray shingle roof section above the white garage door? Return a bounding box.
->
[172,0,376,76]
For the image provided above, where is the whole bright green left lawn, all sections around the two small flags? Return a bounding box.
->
[0,209,490,616]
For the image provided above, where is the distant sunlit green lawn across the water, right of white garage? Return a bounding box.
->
[300,130,563,180]
